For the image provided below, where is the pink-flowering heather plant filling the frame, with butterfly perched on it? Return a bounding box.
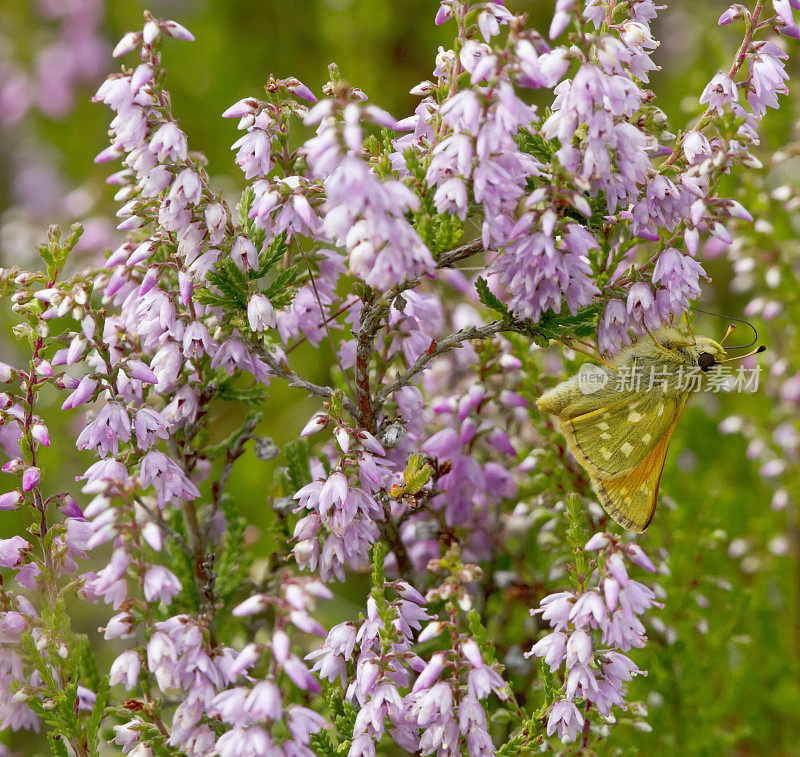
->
[0,0,800,757]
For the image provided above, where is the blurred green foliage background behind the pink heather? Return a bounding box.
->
[0,0,800,755]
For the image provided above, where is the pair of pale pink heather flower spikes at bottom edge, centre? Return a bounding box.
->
[308,553,509,757]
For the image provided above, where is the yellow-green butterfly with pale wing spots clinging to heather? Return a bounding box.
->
[536,327,764,533]
